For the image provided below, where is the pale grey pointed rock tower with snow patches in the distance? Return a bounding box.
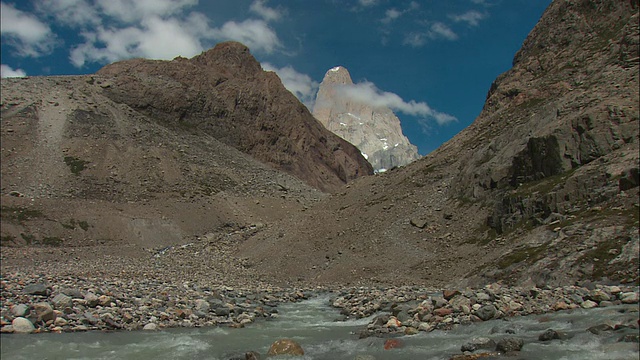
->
[313,66,420,171]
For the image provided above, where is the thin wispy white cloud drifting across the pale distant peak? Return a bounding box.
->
[336,81,457,125]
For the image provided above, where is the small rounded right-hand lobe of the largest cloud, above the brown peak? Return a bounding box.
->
[213,19,282,53]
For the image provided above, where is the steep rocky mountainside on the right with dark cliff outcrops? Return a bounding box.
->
[239,0,640,285]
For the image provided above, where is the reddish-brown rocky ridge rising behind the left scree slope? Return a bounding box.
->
[97,42,372,191]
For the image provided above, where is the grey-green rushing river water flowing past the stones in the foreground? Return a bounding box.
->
[0,297,638,360]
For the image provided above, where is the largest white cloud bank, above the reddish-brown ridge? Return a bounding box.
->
[67,0,282,67]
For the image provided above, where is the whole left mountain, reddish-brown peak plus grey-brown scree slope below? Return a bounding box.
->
[1,43,373,262]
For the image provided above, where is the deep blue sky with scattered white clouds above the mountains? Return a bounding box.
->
[0,0,551,155]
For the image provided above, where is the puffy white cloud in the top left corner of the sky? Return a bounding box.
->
[0,2,55,57]
